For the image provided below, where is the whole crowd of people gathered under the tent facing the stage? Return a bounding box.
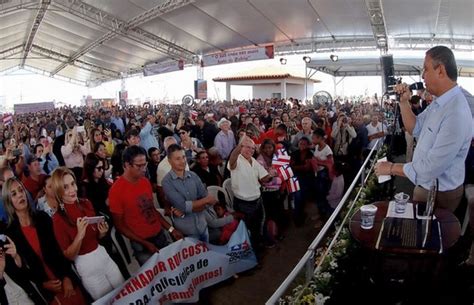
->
[0,97,448,304]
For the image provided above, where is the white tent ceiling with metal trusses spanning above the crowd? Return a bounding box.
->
[0,0,474,84]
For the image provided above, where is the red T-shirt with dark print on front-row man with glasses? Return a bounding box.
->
[109,176,161,239]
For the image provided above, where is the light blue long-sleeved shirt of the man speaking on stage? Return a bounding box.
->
[403,86,473,191]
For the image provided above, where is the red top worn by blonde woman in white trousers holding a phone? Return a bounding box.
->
[53,199,99,255]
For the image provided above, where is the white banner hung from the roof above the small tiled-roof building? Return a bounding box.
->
[202,46,274,67]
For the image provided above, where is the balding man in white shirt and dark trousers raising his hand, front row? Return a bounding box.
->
[227,136,272,257]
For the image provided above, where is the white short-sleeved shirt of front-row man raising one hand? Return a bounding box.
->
[227,155,268,201]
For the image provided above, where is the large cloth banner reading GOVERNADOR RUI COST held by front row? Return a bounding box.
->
[93,221,257,305]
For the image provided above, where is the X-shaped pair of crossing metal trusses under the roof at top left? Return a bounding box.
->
[51,0,194,75]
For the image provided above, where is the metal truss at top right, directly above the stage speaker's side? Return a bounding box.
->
[365,0,388,52]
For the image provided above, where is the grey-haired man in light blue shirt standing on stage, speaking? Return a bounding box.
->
[375,46,473,211]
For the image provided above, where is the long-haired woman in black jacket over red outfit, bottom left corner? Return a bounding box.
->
[2,177,86,305]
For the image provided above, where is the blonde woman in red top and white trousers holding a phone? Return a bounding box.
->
[51,167,124,300]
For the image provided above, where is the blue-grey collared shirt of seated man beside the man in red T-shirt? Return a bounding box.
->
[163,170,207,237]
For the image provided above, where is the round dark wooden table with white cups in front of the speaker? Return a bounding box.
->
[349,201,461,254]
